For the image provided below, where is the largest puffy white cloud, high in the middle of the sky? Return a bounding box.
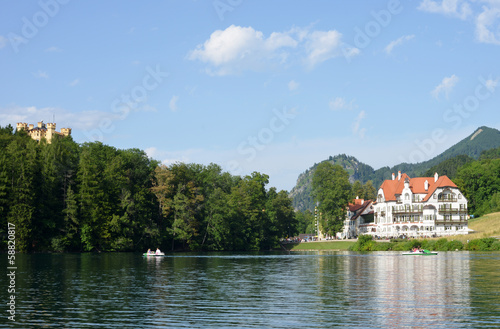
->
[188,25,359,75]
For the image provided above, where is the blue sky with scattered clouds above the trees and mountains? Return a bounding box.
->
[0,0,500,190]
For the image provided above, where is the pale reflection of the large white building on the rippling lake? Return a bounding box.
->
[349,253,470,328]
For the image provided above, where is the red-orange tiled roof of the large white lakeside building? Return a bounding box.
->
[380,174,457,201]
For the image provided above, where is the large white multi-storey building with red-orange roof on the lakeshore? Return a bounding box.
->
[376,172,469,237]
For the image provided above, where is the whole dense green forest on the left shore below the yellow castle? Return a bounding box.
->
[0,125,298,252]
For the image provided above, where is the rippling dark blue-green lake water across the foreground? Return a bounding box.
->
[0,252,500,328]
